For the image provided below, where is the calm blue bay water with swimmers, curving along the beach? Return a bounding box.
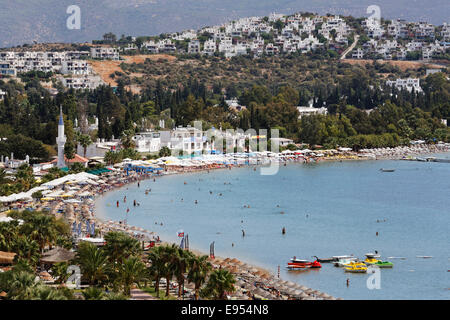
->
[97,154,450,299]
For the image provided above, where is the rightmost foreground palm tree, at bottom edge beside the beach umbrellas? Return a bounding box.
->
[202,269,236,300]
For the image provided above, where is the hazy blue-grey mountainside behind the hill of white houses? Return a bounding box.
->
[0,0,450,47]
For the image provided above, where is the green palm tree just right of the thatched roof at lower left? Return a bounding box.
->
[77,242,110,285]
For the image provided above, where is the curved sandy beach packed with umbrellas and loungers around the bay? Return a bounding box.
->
[1,145,448,299]
